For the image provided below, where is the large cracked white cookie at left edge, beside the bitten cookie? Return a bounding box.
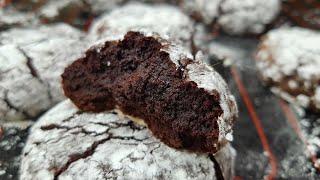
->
[0,24,85,122]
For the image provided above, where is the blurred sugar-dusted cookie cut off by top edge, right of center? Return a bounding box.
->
[180,0,280,35]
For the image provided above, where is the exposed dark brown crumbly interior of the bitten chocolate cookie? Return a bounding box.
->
[62,32,223,152]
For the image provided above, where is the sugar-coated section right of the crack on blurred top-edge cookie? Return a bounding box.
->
[218,0,280,34]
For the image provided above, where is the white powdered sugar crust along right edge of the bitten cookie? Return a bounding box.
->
[160,40,238,147]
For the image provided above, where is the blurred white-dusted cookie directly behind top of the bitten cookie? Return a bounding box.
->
[89,3,195,48]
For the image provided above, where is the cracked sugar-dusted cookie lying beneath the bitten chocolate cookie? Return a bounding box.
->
[20,100,235,180]
